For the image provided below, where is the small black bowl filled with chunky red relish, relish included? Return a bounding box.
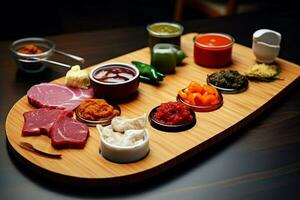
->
[149,102,196,132]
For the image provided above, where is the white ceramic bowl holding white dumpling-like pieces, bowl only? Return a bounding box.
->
[99,128,149,163]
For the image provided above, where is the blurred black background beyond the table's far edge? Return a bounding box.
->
[0,0,293,40]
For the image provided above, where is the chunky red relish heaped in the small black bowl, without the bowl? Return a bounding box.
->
[153,102,193,125]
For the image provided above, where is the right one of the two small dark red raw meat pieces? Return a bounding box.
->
[50,114,89,149]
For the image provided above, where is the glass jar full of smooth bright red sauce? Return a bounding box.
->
[194,33,234,67]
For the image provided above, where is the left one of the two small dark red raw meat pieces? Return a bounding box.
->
[22,108,73,136]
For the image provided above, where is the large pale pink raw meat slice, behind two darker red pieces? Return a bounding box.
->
[27,83,94,110]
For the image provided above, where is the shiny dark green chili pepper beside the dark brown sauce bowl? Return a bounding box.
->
[131,61,165,83]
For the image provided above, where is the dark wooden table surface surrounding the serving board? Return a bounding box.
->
[0,10,300,200]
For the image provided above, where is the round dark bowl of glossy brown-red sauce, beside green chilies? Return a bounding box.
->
[89,63,139,100]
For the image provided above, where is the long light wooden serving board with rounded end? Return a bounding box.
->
[6,33,300,183]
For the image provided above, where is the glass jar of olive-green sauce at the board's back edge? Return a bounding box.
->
[147,22,183,50]
